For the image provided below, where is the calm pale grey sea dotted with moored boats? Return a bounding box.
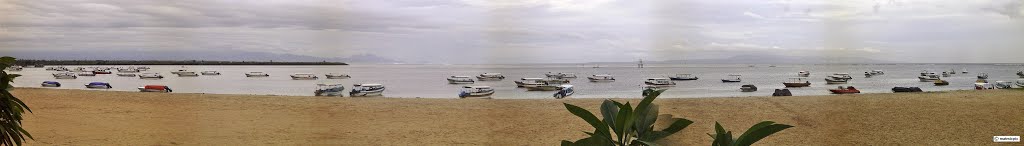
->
[12,64,1024,99]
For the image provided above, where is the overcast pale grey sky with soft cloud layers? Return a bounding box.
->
[0,0,1024,63]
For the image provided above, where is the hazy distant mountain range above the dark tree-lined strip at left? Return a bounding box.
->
[0,50,400,63]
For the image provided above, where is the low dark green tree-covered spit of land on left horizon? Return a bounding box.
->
[17,60,348,65]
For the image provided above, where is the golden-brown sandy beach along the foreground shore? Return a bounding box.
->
[13,88,1024,145]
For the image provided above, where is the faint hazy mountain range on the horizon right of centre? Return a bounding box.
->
[590,55,899,64]
